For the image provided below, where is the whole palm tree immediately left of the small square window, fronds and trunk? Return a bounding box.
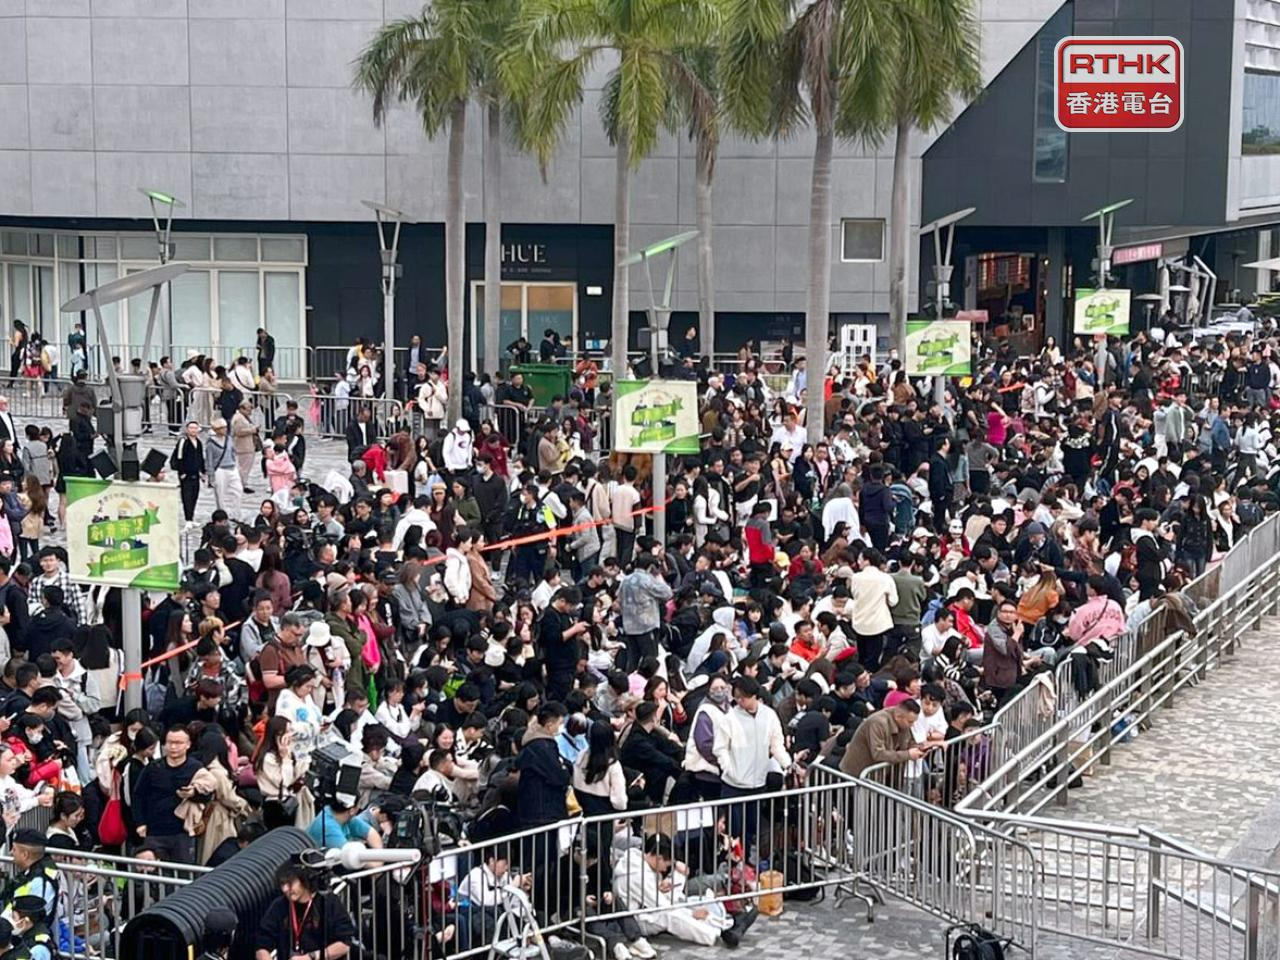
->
[724,0,900,442]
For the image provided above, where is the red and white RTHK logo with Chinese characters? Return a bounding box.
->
[1053,37,1183,133]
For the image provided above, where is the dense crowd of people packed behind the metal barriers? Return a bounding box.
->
[0,321,1280,960]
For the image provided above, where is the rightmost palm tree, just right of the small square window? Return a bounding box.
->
[888,0,982,356]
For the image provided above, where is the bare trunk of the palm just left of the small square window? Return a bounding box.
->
[804,124,836,443]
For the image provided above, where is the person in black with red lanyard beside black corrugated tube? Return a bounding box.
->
[253,863,356,960]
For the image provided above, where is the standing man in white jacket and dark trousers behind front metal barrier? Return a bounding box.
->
[712,677,791,850]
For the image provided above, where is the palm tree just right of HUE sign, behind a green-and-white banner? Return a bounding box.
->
[503,0,718,376]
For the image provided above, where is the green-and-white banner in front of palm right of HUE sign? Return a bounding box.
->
[613,380,701,453]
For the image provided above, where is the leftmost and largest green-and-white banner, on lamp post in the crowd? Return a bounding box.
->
[67,476,182,590]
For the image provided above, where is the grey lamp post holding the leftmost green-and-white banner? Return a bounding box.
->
[63,264,191,710]
